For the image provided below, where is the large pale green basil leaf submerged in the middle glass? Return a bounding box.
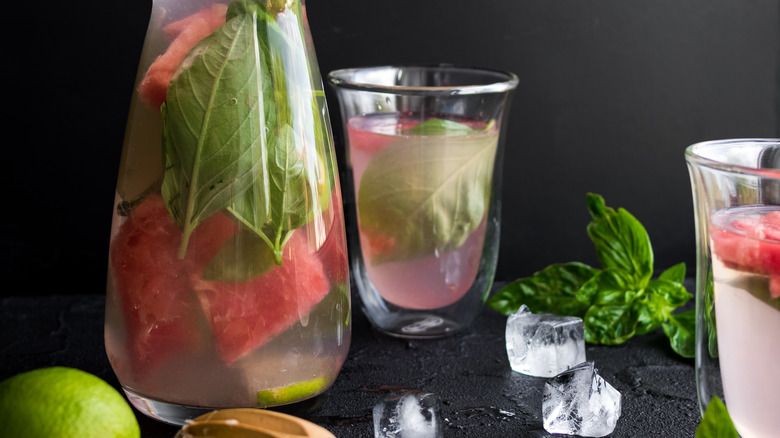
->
[358,126,498,264]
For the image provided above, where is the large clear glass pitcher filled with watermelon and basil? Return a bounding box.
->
[105,0,351,424]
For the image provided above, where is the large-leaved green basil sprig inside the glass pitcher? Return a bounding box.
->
[161,0,330,274]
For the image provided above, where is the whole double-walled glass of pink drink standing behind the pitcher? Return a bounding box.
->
[328,65,518,338]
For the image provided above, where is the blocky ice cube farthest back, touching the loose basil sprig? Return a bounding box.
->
[506,305,585,377]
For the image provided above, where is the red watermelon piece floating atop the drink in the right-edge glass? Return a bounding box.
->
[710,211,780,298]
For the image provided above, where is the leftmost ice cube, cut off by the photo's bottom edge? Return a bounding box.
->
[374,391,444,438]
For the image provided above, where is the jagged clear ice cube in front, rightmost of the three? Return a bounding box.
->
[542,362,621,437]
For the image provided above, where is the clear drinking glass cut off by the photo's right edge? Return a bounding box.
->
[685,139,780,438]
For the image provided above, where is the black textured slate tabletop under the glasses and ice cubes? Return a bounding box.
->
[0,295,699,438]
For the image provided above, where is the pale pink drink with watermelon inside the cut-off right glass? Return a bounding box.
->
[710,206,780,438]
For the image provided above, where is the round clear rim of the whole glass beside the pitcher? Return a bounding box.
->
[328,64,520,95]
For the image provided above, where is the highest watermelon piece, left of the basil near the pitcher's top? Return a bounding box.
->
[138,3,227,109]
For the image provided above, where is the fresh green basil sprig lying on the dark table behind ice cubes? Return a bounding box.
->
[487,193,695,357]
